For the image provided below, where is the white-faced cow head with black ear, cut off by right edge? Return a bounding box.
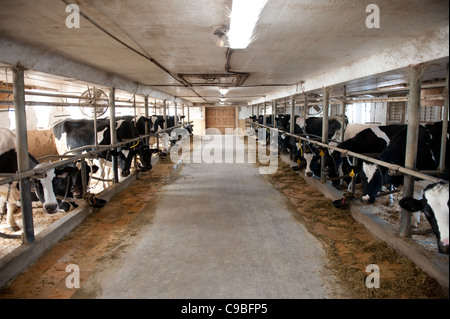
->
[399,182,449,255]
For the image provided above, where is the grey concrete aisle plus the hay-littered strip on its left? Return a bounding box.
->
[2,138,342,299]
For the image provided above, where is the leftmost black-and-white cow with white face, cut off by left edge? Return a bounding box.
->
[0,128,65,231]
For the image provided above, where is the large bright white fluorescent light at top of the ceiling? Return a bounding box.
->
[228,0,267,49]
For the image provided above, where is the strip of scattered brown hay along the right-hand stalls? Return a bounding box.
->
[266,160,448,299]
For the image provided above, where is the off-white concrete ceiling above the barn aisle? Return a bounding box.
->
[0,0,449,104]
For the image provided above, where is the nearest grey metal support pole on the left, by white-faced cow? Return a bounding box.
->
[13,66,34,243]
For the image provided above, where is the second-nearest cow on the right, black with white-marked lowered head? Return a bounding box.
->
[361,125,437,210]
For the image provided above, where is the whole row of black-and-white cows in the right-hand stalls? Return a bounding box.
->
[250,114,450,254]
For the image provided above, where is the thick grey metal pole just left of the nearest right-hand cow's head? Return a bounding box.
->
[399,65,424,238]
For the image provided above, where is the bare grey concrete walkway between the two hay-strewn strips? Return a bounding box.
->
[75,139,342,299]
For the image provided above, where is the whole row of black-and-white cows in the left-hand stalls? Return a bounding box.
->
[0,115,192,236]
